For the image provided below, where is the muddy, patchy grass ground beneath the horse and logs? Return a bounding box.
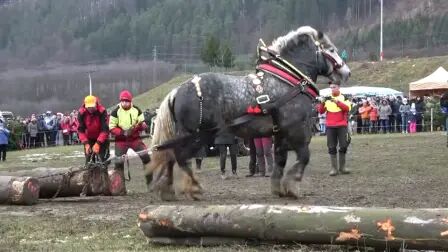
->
[0,132,448,251]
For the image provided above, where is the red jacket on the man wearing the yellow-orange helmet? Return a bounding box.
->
[78,104,109,143]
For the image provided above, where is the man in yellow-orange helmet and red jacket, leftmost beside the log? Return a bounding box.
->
[78,95,109,163]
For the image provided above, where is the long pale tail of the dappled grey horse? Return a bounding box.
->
[145,88,177,180]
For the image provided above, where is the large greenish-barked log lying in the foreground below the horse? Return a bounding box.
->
[138,205,448,250]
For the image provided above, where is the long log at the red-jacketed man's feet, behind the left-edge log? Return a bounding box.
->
[0,168,110,198]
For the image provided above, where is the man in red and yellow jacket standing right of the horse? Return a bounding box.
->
[317,83,351,176]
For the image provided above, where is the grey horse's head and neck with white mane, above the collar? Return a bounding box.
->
[269,26,350,84]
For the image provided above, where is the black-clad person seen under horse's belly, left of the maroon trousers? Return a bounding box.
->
[215,132,238,179]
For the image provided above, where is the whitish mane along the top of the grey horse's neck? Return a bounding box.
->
[269,26,336,53]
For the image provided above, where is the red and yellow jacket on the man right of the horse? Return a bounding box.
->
[317,95,351,128]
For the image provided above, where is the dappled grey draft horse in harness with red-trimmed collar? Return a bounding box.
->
[147,26,350,199]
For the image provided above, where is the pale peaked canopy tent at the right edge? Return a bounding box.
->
[409,67,448,96]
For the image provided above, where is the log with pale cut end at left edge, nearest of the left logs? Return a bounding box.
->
[0,176,39,205]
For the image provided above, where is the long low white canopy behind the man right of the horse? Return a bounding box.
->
[320,86,403,97]
